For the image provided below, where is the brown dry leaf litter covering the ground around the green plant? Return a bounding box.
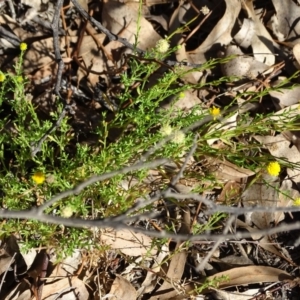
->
[0,0,300,300]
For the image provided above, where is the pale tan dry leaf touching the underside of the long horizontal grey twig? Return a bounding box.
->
[101,229,157,256]
